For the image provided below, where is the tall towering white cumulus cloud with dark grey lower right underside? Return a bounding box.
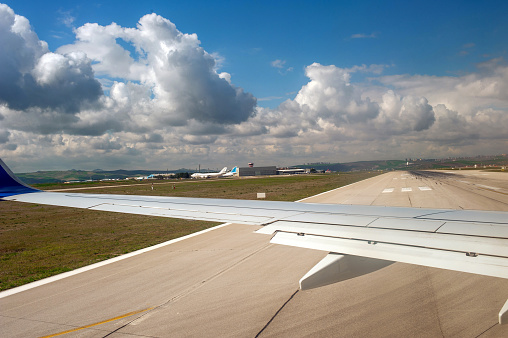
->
[58,14,256,125]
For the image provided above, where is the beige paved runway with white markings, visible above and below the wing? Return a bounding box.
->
[0,171,508,337]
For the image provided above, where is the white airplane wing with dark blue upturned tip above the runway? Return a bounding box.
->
[0,160,508,324]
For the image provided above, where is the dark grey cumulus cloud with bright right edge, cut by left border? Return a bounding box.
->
[0,4,102,114]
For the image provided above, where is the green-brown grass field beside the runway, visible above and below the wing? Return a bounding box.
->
[0,172,378,290]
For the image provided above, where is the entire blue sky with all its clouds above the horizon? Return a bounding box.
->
[0,0,508,172]
